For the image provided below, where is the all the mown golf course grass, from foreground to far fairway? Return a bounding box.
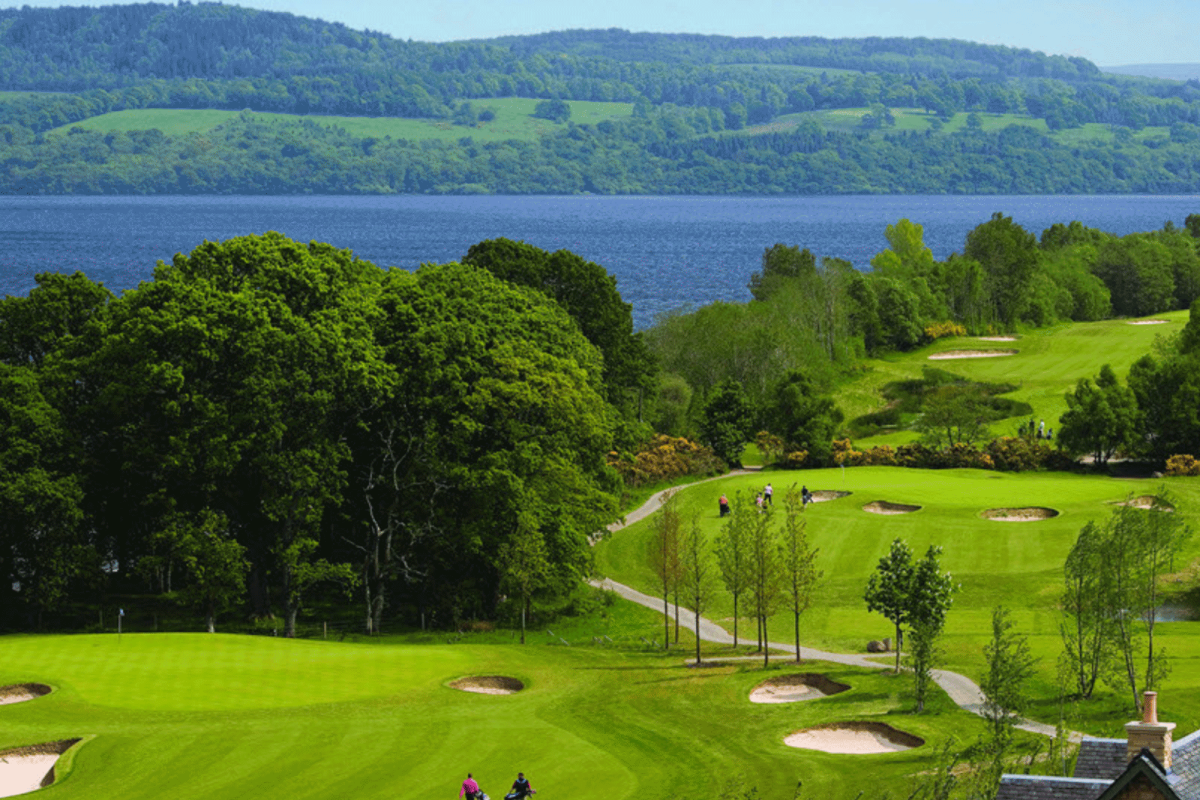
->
[0,313,1200,800]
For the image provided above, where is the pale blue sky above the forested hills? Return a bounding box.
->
[0,0,1200,66]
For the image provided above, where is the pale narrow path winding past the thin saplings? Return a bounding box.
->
[589,469,1065,741]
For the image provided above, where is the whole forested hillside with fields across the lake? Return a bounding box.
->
[7,2,1200,194]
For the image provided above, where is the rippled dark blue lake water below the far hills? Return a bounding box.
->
[0,196,1200,326]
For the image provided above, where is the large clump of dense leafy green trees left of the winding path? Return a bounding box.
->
[0,234,648,634]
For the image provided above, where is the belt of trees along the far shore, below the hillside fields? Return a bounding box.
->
[7,108,1200,194]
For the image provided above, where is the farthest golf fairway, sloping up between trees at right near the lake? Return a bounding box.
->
[836,311,1188,449]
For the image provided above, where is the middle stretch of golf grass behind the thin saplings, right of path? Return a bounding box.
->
[596,468,1200,735]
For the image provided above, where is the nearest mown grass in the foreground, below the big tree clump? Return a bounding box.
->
[0,633,982,800]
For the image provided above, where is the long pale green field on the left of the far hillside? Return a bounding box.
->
[42,97,634,142]
